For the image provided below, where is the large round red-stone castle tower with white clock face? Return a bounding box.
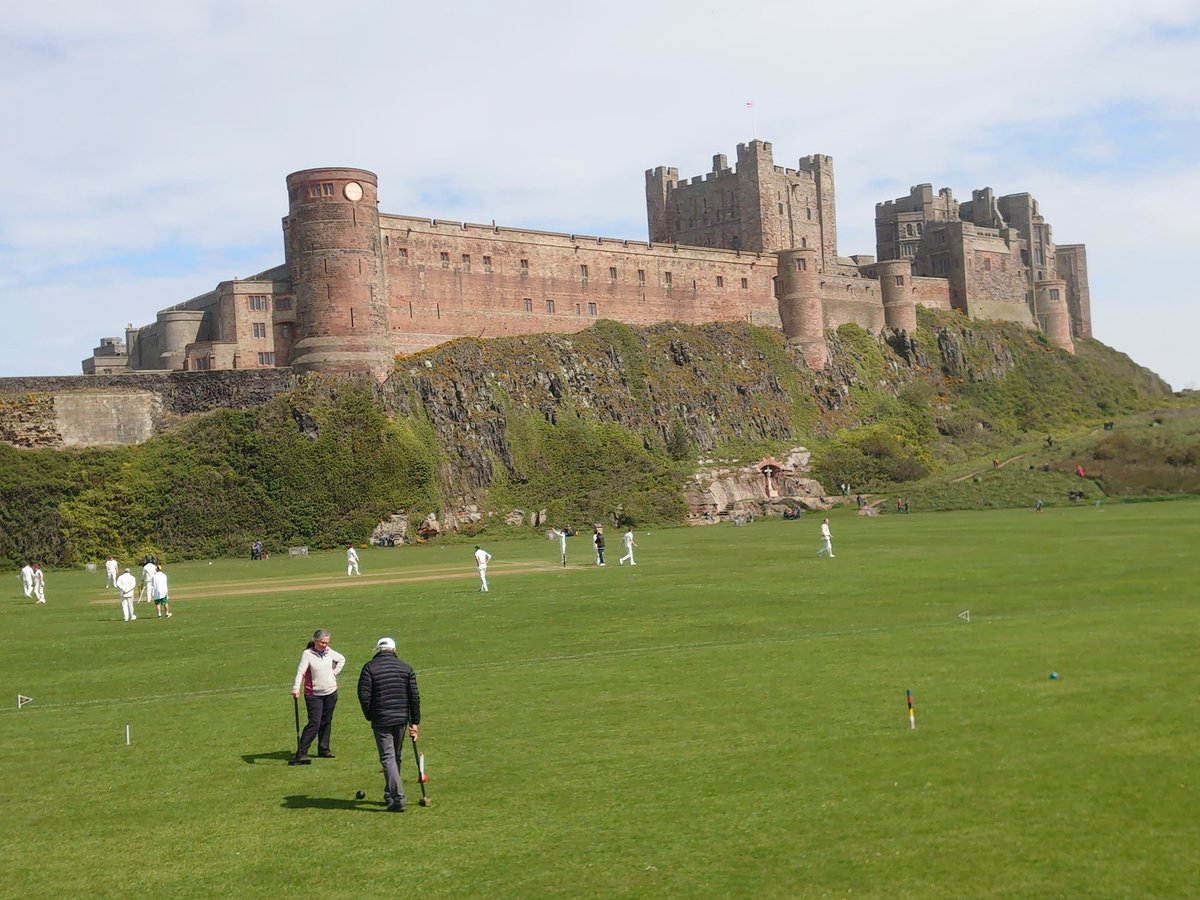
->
[284,168,394,378]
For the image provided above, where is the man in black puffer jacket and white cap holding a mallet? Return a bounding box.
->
[359,637,421,812]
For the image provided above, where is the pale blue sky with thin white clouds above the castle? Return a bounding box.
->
[0,0,1200,390]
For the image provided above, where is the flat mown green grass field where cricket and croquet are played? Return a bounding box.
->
[0,500,1200,898]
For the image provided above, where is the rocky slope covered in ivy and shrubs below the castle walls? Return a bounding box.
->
[0,312,1171,564]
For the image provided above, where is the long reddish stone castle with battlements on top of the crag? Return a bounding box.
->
[83,140,1091,378]
